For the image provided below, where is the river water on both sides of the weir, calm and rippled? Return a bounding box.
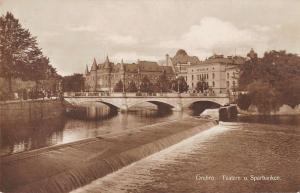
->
[1,106,300,193]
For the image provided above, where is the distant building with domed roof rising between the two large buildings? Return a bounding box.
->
[165,49,200,81]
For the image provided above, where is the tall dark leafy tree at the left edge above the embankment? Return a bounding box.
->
[0,12,53,93]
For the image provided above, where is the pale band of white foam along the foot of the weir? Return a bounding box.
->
[72,125,230,193]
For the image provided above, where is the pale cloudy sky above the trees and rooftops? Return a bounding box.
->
[0,0,300,75]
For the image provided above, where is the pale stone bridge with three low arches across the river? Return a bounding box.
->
[64,92,229,111]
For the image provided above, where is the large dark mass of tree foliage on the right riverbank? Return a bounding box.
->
[239,50,300,113]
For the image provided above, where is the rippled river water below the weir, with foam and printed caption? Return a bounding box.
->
[74,116,300,193]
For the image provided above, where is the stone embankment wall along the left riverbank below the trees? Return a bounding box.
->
[0,99,64,126]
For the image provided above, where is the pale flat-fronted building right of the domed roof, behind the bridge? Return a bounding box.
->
[187,55,246,94]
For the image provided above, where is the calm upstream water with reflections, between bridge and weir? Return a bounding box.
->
[0,106,186,156]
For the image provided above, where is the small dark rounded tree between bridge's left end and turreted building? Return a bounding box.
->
[62,74,84,92]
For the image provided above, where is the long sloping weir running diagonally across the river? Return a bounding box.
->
[1,117,215,193]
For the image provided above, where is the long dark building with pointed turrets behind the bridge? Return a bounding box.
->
[85,57,175,92]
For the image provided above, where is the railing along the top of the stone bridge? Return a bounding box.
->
[64,92,228,97]
